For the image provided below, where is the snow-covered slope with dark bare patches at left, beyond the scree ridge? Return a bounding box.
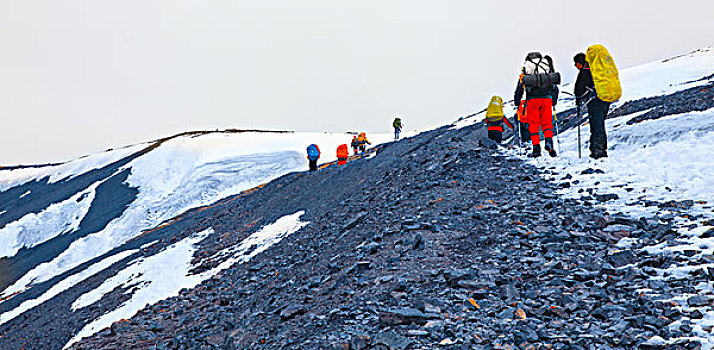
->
[0,131,392,330]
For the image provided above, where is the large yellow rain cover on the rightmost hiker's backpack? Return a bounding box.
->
[585,45,622,102]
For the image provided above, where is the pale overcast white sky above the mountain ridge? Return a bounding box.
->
[0,0,714,165]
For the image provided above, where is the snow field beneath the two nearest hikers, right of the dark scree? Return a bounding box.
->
[511,109,714,217]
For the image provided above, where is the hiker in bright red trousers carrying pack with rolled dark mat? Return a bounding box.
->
[513,52,560,157]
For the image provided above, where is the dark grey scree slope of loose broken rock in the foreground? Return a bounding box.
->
[72,121,698,349]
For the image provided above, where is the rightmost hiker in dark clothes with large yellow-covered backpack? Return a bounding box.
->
[573,45,622,159]
